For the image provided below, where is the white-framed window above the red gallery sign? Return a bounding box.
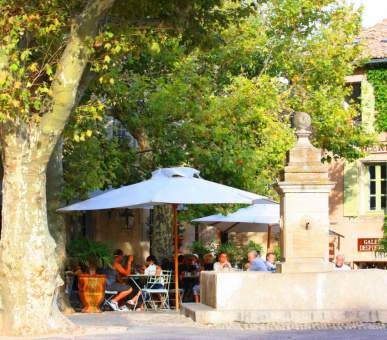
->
[367,163,387,212]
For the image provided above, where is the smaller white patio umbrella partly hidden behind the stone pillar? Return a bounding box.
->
[191,201,280,251]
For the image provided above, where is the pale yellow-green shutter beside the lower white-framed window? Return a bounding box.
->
[344,162,359,216]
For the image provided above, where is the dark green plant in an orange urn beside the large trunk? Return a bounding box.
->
[67,237,114,313]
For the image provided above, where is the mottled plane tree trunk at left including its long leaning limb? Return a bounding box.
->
[0,0,114,336]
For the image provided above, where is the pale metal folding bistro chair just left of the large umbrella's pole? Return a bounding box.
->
[141,270,172,311]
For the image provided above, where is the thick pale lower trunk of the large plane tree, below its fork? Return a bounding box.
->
[0,120,70,336]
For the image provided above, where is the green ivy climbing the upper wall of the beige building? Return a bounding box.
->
[367,64,387,132]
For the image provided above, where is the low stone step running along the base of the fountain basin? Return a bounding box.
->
[180,303,387,324]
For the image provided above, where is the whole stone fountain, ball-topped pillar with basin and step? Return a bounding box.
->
[181,113,387,323]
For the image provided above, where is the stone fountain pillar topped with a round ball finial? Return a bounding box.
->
[272,112,335,273]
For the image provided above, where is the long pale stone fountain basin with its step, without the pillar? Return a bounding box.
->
[194,269,387,323]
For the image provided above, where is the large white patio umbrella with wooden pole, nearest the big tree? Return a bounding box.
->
[58,168,271,309]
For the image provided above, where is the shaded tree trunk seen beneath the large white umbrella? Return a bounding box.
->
[152,204,173,261]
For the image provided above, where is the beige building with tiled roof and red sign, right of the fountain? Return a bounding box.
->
[329,20,387,269]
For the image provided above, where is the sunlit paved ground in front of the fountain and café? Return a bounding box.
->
[0,311,387,340]
